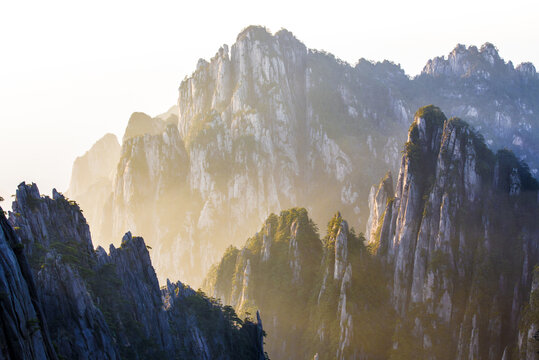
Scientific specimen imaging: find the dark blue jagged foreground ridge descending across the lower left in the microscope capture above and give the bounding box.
[2,183,264,359]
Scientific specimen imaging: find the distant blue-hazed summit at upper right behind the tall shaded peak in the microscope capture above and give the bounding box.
[414,43,539,170]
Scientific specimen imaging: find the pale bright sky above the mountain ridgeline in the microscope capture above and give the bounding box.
[0,0,539,202]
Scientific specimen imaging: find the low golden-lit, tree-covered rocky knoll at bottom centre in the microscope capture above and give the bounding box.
[204,208,393,359]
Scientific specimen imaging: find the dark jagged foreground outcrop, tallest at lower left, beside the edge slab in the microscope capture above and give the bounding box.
[10,184,119,359]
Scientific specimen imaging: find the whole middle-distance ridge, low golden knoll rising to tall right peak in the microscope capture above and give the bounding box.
[204,106,539,360]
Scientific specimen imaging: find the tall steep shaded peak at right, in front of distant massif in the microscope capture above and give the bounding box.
[372,106,539,359]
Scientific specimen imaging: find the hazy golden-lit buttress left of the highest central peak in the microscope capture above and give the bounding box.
[108,125,192,281]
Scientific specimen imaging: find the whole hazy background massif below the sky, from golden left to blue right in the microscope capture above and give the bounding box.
[70,26,539,286]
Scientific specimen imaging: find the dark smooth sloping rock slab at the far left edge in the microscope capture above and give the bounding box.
[0,208,57,360]
